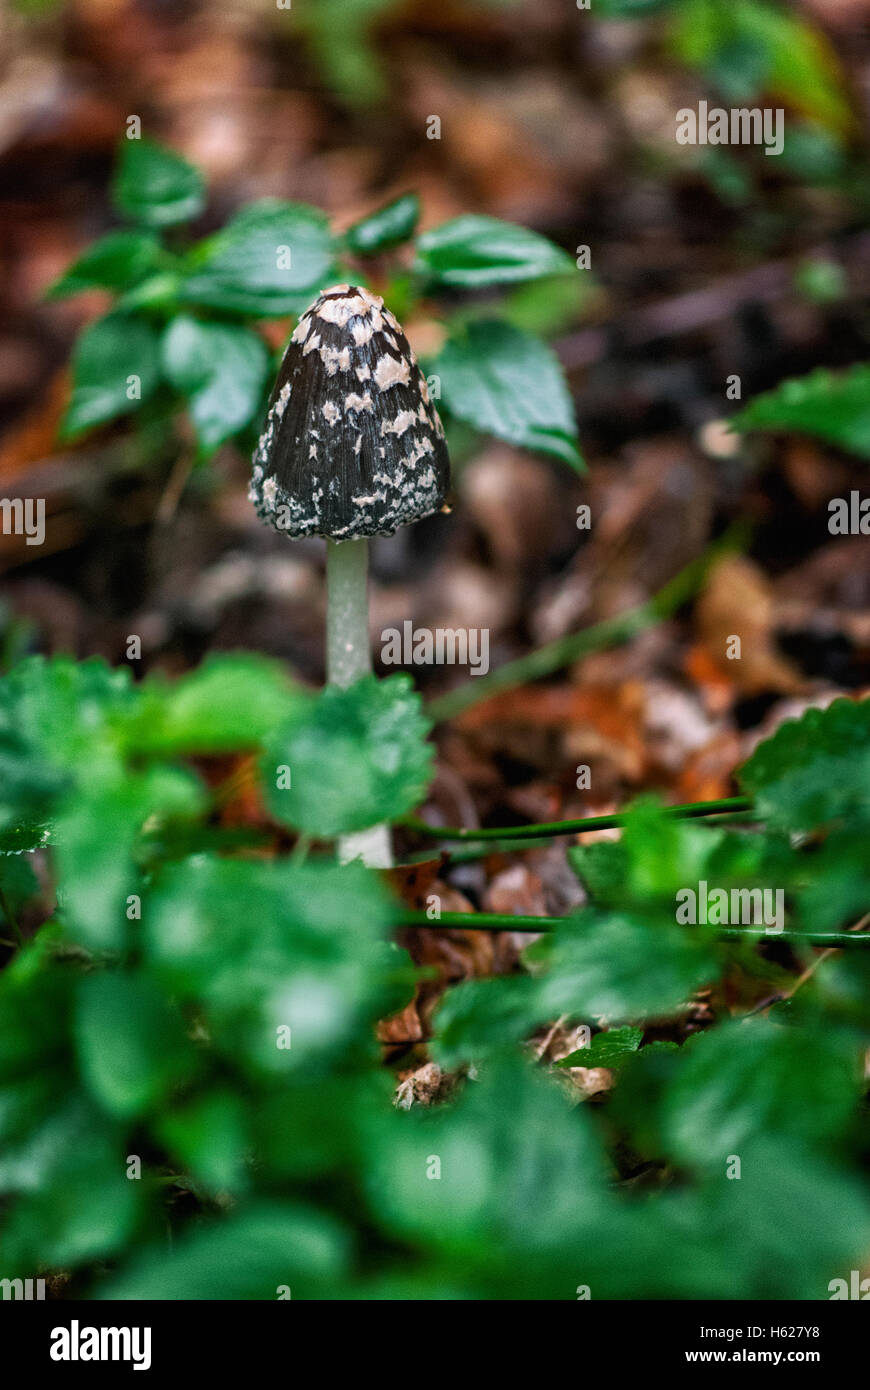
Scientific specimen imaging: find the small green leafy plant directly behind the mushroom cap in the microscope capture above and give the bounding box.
[50,138,584,468]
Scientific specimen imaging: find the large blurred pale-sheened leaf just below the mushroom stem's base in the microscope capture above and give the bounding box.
[142,855,393,1077]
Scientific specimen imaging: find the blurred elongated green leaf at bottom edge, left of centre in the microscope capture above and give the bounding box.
[100,1206,349,1302]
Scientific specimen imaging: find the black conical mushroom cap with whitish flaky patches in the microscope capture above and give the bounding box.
[250,285,450,541]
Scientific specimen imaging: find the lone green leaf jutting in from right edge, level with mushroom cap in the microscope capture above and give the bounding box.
[728,363,870,459]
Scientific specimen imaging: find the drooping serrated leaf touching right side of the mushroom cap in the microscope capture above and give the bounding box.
[432,320,584,471]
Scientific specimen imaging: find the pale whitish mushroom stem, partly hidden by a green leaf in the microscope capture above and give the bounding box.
[327,539,393,869]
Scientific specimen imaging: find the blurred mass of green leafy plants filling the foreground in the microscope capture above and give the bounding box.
[0,639,870,1300]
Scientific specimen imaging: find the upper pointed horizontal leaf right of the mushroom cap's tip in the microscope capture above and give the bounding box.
[416,213,575,289]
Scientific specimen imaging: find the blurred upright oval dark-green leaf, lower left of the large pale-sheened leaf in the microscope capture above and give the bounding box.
[74,972,195,1118]
